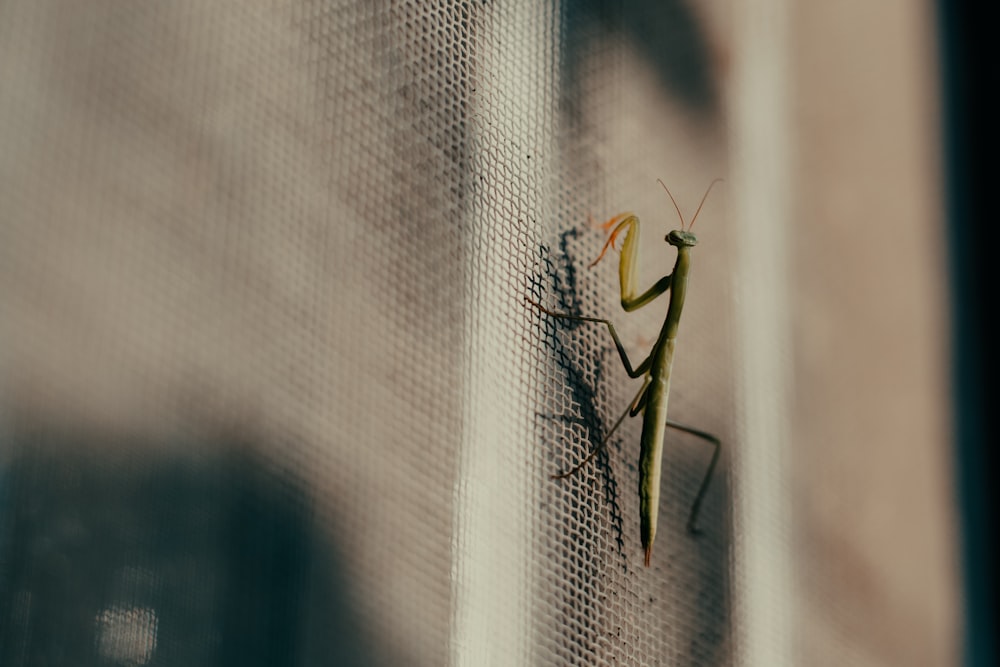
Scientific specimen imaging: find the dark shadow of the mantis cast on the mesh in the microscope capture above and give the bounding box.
[530,228,628,572]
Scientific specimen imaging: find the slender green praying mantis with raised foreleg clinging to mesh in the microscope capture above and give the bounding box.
[525,179,722,567]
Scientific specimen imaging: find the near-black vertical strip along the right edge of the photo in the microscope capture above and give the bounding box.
[937,0,1000,667]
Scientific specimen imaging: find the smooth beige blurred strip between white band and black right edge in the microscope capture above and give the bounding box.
[792,2,958,665]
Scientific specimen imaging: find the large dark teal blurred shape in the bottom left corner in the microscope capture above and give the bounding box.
[0,437,371,667]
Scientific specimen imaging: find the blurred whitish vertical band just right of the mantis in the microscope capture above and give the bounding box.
[730,0,795,667]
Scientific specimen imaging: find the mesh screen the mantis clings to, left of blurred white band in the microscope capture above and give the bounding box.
[0,0,735,665]
